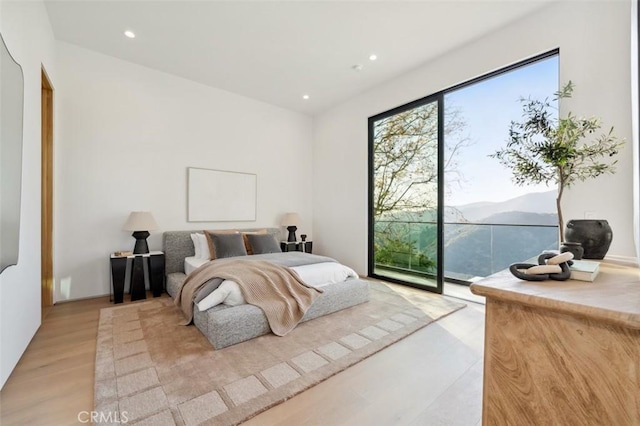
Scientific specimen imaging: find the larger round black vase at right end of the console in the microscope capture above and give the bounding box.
[564,219,613,259]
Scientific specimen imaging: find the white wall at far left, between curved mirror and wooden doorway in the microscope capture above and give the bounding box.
[0,1,57,388]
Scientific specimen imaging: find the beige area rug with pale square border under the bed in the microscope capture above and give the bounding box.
[95,281,465,426]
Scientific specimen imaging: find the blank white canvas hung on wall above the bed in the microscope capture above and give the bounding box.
[187,167,257,222]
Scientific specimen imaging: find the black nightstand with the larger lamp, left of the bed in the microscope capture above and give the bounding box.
[111,251,164,303]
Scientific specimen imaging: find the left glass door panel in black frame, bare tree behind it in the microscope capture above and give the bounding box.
[369,96,443,293]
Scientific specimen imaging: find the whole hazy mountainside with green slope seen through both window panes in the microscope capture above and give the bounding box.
[378,191,558,280]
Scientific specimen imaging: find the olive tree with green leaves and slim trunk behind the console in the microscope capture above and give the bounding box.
[490,81,625,257]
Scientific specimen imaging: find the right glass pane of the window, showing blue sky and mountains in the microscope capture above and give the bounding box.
[443,56,559,283]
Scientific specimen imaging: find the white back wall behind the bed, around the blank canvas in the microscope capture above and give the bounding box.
[54,42,313,301]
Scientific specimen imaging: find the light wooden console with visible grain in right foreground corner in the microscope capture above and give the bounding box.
[471,262,640,426]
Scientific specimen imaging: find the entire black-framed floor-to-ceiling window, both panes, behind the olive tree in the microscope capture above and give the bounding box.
[369,51,558,292]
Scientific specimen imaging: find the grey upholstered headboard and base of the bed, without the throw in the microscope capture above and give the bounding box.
[163,228,369,349]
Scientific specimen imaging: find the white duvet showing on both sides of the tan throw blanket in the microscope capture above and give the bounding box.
[196,259,358,311]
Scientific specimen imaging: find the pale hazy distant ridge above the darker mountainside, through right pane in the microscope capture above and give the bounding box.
[448,190,557,224]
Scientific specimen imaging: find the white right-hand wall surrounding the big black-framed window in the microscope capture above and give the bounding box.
[313,0,635,273]
